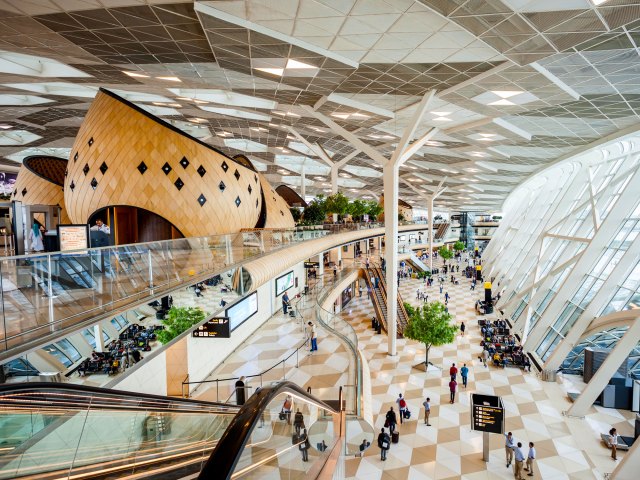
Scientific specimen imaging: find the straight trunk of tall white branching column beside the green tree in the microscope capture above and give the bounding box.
[382,162,400,356]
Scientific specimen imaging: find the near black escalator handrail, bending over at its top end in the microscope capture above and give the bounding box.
[198,382,339,480]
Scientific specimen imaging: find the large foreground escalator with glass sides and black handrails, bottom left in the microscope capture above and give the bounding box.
[0,382,338,480]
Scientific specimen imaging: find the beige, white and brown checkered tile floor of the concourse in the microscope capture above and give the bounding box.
[200,258,634,480]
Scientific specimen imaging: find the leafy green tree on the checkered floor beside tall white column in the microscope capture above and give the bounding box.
[403,302,458,371]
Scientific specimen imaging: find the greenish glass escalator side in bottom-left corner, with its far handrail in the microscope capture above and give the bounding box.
[0,384,238,479]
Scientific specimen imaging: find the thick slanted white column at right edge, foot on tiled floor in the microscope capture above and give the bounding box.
[567,317,640,417]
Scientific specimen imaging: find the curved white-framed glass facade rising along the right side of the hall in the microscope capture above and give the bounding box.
[484,134,640,369]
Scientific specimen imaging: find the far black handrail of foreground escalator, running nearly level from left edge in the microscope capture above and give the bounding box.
[0,382,239,414]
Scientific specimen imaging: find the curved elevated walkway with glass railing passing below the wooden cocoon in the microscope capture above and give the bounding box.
[0,225,422,363]
